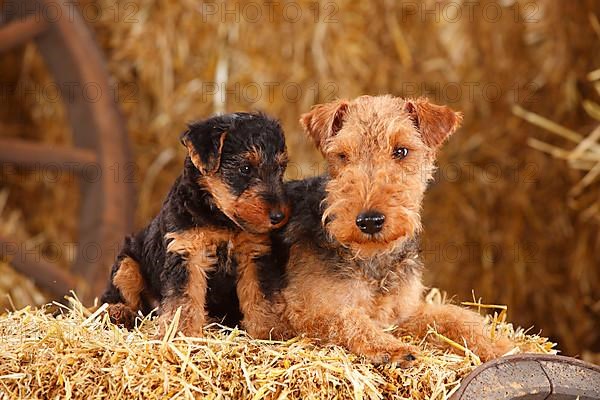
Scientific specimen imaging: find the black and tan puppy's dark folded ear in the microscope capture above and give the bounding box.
[181,119,227,174]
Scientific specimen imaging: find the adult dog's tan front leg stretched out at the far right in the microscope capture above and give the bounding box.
[400,303,514,362]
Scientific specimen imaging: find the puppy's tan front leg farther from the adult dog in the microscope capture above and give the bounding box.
[159,244,217,336]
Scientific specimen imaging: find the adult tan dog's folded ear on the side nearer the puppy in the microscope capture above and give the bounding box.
[300,100,348,151]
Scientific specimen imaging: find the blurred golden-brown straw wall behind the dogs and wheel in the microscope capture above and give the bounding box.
[0,0,600,355]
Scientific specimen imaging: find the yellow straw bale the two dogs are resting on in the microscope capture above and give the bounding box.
[0,296,556,400]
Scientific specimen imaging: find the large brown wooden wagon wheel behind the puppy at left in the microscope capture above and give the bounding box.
[0,0,133,301]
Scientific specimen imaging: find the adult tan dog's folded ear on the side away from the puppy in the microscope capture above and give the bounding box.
[403,98,462,149]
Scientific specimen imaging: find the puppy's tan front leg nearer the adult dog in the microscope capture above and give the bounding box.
[234,232,291,339]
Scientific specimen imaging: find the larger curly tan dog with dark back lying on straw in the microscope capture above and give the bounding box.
[240,96,511,364]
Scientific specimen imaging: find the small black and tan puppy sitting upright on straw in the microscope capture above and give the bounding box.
[101,113,288,336]
